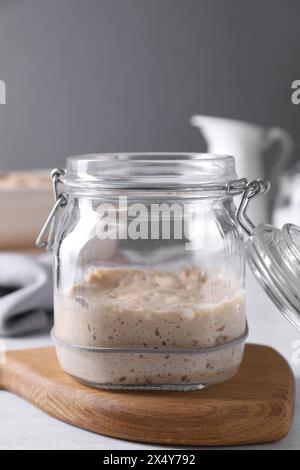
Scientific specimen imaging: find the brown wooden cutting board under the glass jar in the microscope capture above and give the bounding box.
[0,345,295,446]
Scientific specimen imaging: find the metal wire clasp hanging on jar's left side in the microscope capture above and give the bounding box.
[35,168,68,250]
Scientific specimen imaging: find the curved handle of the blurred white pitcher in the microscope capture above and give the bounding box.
[267,127,294,183]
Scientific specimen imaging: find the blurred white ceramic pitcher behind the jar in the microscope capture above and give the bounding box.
[191,115,294,222]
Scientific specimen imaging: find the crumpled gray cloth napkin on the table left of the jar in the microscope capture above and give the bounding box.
[0,253,53,336]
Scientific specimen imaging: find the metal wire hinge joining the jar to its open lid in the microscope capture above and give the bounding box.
[233,179,271,235]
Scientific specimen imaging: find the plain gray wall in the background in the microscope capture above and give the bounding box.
[0,0,300,169]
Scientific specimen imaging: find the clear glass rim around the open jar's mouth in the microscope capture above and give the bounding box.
[64,152,237,190]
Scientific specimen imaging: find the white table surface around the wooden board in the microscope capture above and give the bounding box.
[0,266,300,450]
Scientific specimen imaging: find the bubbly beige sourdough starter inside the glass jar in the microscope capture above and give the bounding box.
[55,267,246,387]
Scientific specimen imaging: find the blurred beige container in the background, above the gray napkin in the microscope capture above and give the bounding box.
[0,170,53,249]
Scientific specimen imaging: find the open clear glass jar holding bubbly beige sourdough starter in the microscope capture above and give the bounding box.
[37,154,258,390]
